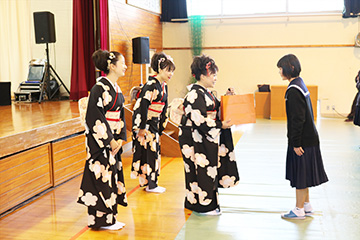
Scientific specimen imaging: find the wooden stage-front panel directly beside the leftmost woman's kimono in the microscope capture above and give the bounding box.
[52,134,86,186]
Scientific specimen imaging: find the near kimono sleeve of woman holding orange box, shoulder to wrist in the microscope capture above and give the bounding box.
[185,90,222,139]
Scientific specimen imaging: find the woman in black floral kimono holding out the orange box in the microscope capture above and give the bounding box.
[179,55,239,215]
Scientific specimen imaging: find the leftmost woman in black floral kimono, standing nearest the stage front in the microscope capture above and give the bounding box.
[78,49,127,230]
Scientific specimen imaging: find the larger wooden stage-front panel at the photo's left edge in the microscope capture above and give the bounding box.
[0,144,52,214]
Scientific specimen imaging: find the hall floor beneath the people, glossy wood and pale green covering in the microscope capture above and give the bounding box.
[0,102,360,240]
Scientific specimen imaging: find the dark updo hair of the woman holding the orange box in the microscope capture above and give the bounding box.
[190,54,219,81]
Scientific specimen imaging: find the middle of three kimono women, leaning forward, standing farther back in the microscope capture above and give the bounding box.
[131,53,175,193]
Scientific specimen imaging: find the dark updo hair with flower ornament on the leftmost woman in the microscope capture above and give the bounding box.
[92,49,122,74]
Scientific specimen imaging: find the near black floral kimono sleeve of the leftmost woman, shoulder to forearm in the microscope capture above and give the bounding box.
[85,85,114,148]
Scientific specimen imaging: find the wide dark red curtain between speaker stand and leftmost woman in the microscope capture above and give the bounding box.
[70,0,95,100]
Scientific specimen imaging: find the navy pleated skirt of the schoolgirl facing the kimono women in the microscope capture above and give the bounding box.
[286,146,328,189]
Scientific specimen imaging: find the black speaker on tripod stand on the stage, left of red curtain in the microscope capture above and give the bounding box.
[34,12,70,103]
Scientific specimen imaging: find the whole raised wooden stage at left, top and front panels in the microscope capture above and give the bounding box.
[0,100,86,214]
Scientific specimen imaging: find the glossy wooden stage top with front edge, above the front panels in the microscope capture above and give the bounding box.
[0,101,84,158]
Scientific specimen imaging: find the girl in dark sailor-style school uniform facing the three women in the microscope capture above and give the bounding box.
[277,54,328,219]
